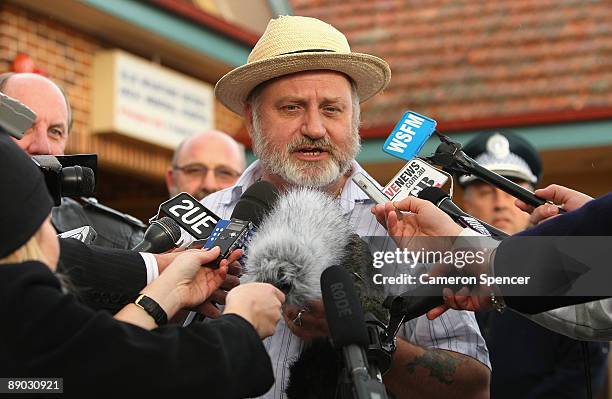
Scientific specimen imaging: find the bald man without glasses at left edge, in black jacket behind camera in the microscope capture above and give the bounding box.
[0,73,146,249]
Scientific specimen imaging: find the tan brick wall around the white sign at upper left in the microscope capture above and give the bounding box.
[0,4,242,178]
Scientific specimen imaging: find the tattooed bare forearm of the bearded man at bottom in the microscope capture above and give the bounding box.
[384,338,491,399]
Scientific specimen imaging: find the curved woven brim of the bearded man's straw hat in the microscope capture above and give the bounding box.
[215,52,391,114]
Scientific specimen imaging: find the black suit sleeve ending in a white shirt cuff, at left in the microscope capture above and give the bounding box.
[58,238,147,312]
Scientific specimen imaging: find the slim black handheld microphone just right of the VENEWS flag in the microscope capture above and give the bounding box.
[418,187,509,239]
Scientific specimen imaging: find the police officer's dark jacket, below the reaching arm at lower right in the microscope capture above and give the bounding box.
[476,311,608,399]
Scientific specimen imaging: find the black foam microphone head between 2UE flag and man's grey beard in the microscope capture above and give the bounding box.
[231,180,278,226]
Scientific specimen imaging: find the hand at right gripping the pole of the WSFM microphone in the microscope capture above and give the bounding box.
[515,184,593,225]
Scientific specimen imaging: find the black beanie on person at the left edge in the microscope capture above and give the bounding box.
[0,132,53,258]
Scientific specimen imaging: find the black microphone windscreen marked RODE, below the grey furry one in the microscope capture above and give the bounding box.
[321,266,370,348]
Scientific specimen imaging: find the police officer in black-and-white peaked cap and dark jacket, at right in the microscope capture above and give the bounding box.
[458,130,608,399]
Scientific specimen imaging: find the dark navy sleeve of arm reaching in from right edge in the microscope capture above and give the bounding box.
[494,193,612,314]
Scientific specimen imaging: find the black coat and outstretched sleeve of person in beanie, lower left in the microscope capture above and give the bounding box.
[0,262,274,398]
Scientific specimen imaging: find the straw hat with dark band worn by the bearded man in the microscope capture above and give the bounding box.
[215,16,391,114]
